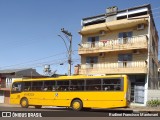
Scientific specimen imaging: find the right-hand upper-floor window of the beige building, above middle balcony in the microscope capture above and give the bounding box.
[118,32,132,44]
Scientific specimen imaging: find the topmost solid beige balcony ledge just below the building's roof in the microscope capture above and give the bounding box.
[79,15,148,35]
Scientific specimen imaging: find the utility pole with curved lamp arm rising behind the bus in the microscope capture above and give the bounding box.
[58,28,72,76]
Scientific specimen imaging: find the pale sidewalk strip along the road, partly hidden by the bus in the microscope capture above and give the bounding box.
[0,103,160,112]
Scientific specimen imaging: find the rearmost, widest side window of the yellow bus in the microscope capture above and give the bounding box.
[102,79,123,91]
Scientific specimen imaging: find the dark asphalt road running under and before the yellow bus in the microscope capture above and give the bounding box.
[0,107,160,120]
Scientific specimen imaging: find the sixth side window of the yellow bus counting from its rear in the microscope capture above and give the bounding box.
[32,81,43,91]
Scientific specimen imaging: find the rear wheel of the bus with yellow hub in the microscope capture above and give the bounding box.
[71,99,83,111]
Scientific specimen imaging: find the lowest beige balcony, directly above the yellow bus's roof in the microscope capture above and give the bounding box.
[79,61,147,75]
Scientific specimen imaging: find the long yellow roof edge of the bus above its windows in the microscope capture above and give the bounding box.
[14,75,127,82]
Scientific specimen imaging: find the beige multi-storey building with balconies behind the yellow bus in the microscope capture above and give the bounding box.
[75,4,160,105]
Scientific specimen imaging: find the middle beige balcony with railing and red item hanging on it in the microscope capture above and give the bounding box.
[78,35,148,54]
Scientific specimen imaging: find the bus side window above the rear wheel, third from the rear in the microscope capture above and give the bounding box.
[70,80,84,91]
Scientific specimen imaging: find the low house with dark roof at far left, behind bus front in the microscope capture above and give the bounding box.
[0,69,41,103]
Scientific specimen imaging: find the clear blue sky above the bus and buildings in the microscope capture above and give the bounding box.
[0,0,160,74]
